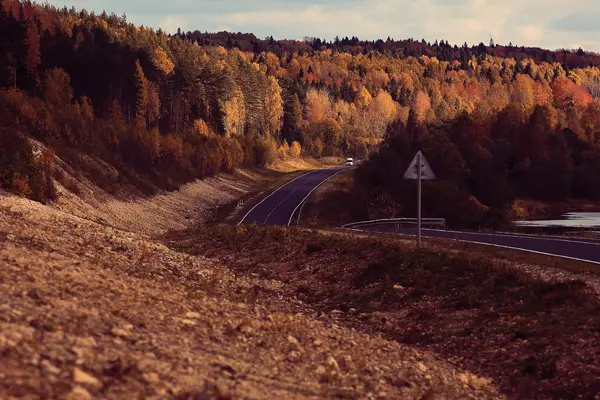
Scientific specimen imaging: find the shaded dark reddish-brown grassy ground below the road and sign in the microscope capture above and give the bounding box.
[167,226,600,398]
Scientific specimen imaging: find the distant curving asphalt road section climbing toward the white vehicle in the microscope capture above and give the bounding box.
[240,167,348,226]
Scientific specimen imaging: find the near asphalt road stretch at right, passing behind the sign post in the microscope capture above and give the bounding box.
[360,226,600,264]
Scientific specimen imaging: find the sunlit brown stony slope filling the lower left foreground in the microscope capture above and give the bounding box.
[0,193,502,399]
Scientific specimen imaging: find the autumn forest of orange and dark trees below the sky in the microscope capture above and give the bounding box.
[0,0,600,226]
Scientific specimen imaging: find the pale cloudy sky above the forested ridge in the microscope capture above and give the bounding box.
[50,0,600,52]
